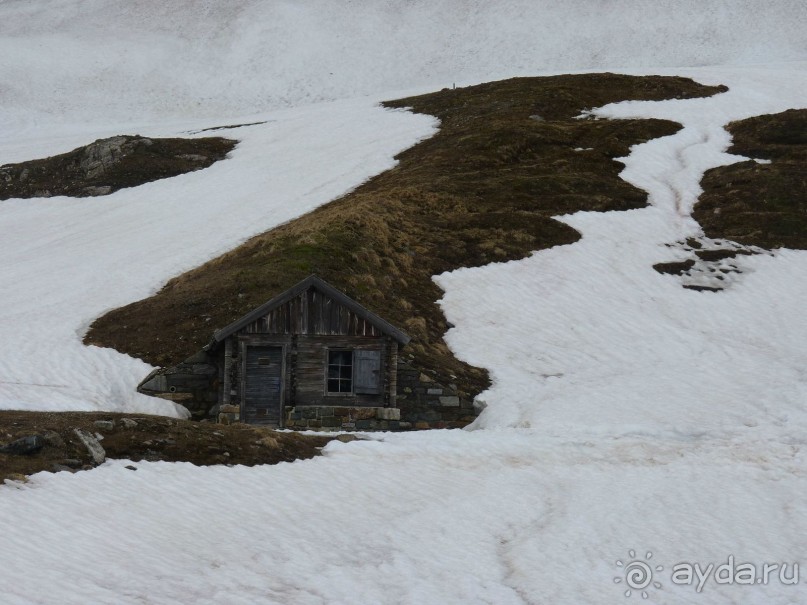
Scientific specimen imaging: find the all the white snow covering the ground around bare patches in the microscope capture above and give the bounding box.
[0,0,807,605]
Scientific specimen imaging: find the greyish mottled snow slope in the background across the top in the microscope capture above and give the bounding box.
[0,0,807,123]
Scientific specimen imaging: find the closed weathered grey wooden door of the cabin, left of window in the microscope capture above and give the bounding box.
[243,346,283,426]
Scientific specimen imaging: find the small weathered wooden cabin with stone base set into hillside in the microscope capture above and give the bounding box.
[138,276,409,428]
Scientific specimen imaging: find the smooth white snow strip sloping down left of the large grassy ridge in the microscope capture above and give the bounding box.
[0,101,434,415]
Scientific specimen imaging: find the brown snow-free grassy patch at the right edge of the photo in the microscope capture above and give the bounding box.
[693,109,807,249]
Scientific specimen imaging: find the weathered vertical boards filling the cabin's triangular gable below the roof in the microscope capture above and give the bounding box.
[240,288,382,337]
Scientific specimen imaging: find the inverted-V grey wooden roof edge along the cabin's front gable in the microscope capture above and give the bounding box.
[205,275,411,349]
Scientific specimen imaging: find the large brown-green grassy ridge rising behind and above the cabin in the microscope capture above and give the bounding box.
[86,74,722,396]
